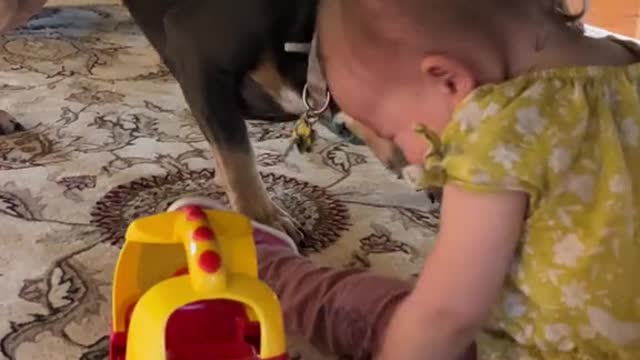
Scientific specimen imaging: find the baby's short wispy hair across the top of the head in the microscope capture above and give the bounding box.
[318,0,588,71]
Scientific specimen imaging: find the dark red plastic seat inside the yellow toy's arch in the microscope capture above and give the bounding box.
[165,300,260,360]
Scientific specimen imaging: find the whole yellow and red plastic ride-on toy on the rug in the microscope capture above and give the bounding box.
[109,206,288,360]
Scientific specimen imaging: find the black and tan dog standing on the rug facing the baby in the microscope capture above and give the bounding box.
[0,0,410,240]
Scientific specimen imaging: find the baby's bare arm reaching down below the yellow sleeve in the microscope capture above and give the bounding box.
[377,185,528,360]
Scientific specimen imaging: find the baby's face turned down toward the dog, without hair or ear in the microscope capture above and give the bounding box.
[321,39,454,164]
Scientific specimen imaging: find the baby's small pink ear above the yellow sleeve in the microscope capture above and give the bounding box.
[420,55,476,105]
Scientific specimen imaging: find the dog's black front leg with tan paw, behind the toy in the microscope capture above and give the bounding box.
[165,0,302,239]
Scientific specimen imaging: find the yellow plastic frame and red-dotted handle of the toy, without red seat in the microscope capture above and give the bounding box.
[113,207,286,360]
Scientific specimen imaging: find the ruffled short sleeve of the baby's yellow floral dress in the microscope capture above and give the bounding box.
[423,82,553,202]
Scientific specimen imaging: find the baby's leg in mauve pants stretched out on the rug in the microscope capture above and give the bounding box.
[258,246,412,359]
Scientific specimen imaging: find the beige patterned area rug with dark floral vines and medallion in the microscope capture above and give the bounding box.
[0,1,437,360]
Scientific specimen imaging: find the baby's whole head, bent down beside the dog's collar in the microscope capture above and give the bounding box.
[318,0,584,163]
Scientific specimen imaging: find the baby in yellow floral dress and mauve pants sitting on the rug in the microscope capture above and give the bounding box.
[174,0,640,360]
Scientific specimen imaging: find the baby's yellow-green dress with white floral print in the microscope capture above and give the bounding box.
[424,64,640,360]
